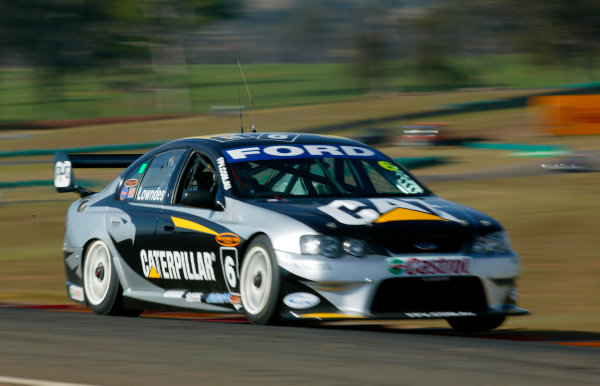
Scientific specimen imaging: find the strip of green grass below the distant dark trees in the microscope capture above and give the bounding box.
[0,55,593,122]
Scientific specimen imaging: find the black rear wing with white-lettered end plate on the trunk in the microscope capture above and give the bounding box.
[54,152,142,197]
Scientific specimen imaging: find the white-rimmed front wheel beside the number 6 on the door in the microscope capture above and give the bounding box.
[240,235,281,325]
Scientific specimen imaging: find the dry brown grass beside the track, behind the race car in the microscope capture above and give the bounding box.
[0,94,600,331]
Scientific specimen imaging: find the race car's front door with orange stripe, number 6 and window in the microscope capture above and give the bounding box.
[156,151,241,305]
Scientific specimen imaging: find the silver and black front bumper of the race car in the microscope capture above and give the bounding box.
[276,251,529,320]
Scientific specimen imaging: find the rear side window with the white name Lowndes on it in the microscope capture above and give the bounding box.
[136,149,185,202]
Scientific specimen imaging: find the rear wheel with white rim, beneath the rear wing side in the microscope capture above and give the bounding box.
[83,240,142,316]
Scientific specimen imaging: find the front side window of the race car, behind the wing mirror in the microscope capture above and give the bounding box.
[176,152,218,202]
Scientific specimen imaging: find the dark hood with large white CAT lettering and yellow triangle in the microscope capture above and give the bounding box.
[250,196,502,253]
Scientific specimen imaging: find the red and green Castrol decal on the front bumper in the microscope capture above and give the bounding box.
[383,257,471,276]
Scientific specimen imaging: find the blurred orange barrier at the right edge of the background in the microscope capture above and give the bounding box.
[528,95,600,135]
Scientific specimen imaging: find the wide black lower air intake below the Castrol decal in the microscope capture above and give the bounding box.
[371,276,487,316]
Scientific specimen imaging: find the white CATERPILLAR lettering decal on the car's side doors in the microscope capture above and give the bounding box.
[140,249,217,281]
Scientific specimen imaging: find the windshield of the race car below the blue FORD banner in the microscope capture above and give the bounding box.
[228,157,427,198]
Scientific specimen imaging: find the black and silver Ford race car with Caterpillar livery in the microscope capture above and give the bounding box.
[54,133,528,332]
